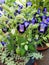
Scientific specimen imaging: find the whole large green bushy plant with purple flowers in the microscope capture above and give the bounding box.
[0,0,49,64]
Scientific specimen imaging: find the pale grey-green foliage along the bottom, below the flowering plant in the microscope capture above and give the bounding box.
[0,44,43,65]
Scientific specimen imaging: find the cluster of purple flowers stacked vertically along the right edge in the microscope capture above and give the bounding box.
[38,7,49,33]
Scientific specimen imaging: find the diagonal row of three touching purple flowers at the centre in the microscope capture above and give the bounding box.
[17,18,37,33]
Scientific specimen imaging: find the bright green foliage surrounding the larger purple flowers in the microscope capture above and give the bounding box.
[0,0,49,56]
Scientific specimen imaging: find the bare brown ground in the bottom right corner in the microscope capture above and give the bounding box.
[37,49,49,65]
